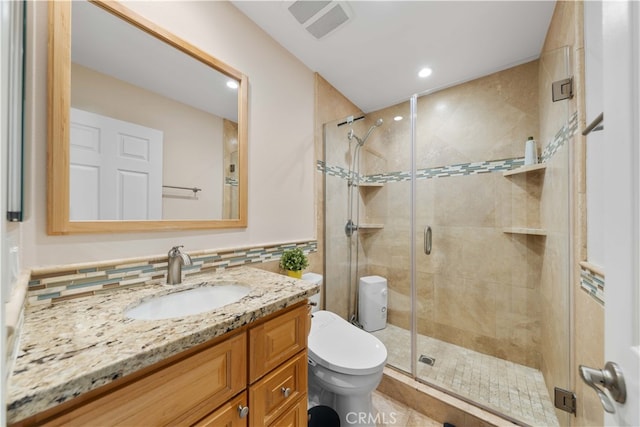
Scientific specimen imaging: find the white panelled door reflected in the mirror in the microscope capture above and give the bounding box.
[69,108,163,221]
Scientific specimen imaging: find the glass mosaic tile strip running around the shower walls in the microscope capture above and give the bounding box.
[316,112,578,184]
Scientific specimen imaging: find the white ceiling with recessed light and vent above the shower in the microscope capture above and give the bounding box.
[232,0,555,112]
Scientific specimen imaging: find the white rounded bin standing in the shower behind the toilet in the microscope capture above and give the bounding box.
[358,276,387,332]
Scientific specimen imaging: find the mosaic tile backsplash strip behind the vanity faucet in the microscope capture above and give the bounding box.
[27,240,318,305]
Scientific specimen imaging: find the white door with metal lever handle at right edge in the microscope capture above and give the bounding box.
[599,1,640,426]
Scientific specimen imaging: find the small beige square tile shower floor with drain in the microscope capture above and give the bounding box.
[373,324,559,426]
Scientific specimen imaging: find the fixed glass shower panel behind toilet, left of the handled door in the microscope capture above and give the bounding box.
[321,102,412,373]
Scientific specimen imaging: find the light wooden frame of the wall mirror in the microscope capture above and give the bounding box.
[47,1,249,235]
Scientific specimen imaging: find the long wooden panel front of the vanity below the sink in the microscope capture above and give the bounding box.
[40,334,247,426]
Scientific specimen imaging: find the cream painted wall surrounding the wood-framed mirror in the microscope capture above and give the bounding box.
[20,1,316,268]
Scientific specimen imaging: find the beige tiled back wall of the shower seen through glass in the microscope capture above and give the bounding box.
[361,61,544,367]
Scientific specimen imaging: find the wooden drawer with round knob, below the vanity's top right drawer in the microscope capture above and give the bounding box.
[249,351,307,426]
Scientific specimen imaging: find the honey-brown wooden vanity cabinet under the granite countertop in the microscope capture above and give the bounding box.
[14,303,310,427]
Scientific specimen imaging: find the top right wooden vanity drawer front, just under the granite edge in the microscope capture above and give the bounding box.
[249,305,309,383]
